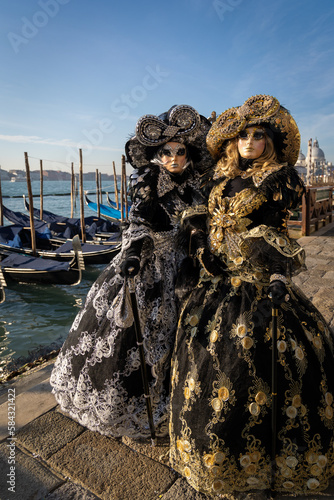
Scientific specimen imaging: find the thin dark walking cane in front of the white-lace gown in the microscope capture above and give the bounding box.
[129,267,157,446]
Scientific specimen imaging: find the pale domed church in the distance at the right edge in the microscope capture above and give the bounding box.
[296,139,334,181]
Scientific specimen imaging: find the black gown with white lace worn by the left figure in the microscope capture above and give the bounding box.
[51,165,203,438]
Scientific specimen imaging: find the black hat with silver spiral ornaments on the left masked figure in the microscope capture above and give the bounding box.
[125,104,212,170]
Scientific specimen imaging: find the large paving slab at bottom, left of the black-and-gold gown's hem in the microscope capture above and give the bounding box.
[48,431,177,500]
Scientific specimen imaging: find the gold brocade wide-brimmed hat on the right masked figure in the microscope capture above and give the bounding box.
[206,95,300,165]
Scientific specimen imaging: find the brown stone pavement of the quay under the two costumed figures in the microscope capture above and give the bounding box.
[0,223,334,500]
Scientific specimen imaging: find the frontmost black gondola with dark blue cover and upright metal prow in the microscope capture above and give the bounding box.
[0,236,85,290]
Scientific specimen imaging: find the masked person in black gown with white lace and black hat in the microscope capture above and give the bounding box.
[51,105,212,438]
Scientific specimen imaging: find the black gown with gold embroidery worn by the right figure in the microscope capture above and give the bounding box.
[170,166,334,498]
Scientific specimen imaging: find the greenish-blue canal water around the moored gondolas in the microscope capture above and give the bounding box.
[0,181,118,378]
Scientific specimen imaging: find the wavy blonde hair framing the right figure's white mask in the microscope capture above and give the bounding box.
[217,135,279,177]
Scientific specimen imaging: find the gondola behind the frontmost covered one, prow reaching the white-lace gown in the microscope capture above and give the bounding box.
[0,224,120,264]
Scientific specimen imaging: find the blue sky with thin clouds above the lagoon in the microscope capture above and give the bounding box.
[0,0,334,174]
